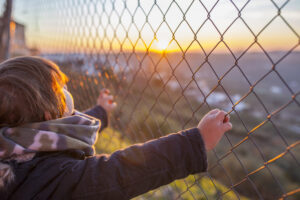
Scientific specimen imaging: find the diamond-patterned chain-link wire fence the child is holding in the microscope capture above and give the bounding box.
[2,0,300,199]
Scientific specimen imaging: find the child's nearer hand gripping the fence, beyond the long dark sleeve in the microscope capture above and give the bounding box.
[197,109,232,150]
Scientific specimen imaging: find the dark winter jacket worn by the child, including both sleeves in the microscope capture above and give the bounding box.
[0,106,207,200]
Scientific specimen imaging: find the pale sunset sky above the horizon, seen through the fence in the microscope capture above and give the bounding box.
[9,0,300,53]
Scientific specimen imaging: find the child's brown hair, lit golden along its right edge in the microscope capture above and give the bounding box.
[0,57,67,127]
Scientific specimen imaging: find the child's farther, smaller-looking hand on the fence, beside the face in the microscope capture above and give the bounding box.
[97,89,117,112]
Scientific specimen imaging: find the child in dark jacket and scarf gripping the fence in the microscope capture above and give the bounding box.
[0,57,232,200]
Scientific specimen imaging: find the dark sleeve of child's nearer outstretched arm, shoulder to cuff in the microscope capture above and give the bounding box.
[74,128,207,199]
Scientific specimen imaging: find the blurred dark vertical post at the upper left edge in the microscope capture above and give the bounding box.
[0,0,13,60]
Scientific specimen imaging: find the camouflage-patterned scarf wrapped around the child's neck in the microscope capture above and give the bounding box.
[0,111,101,161]
